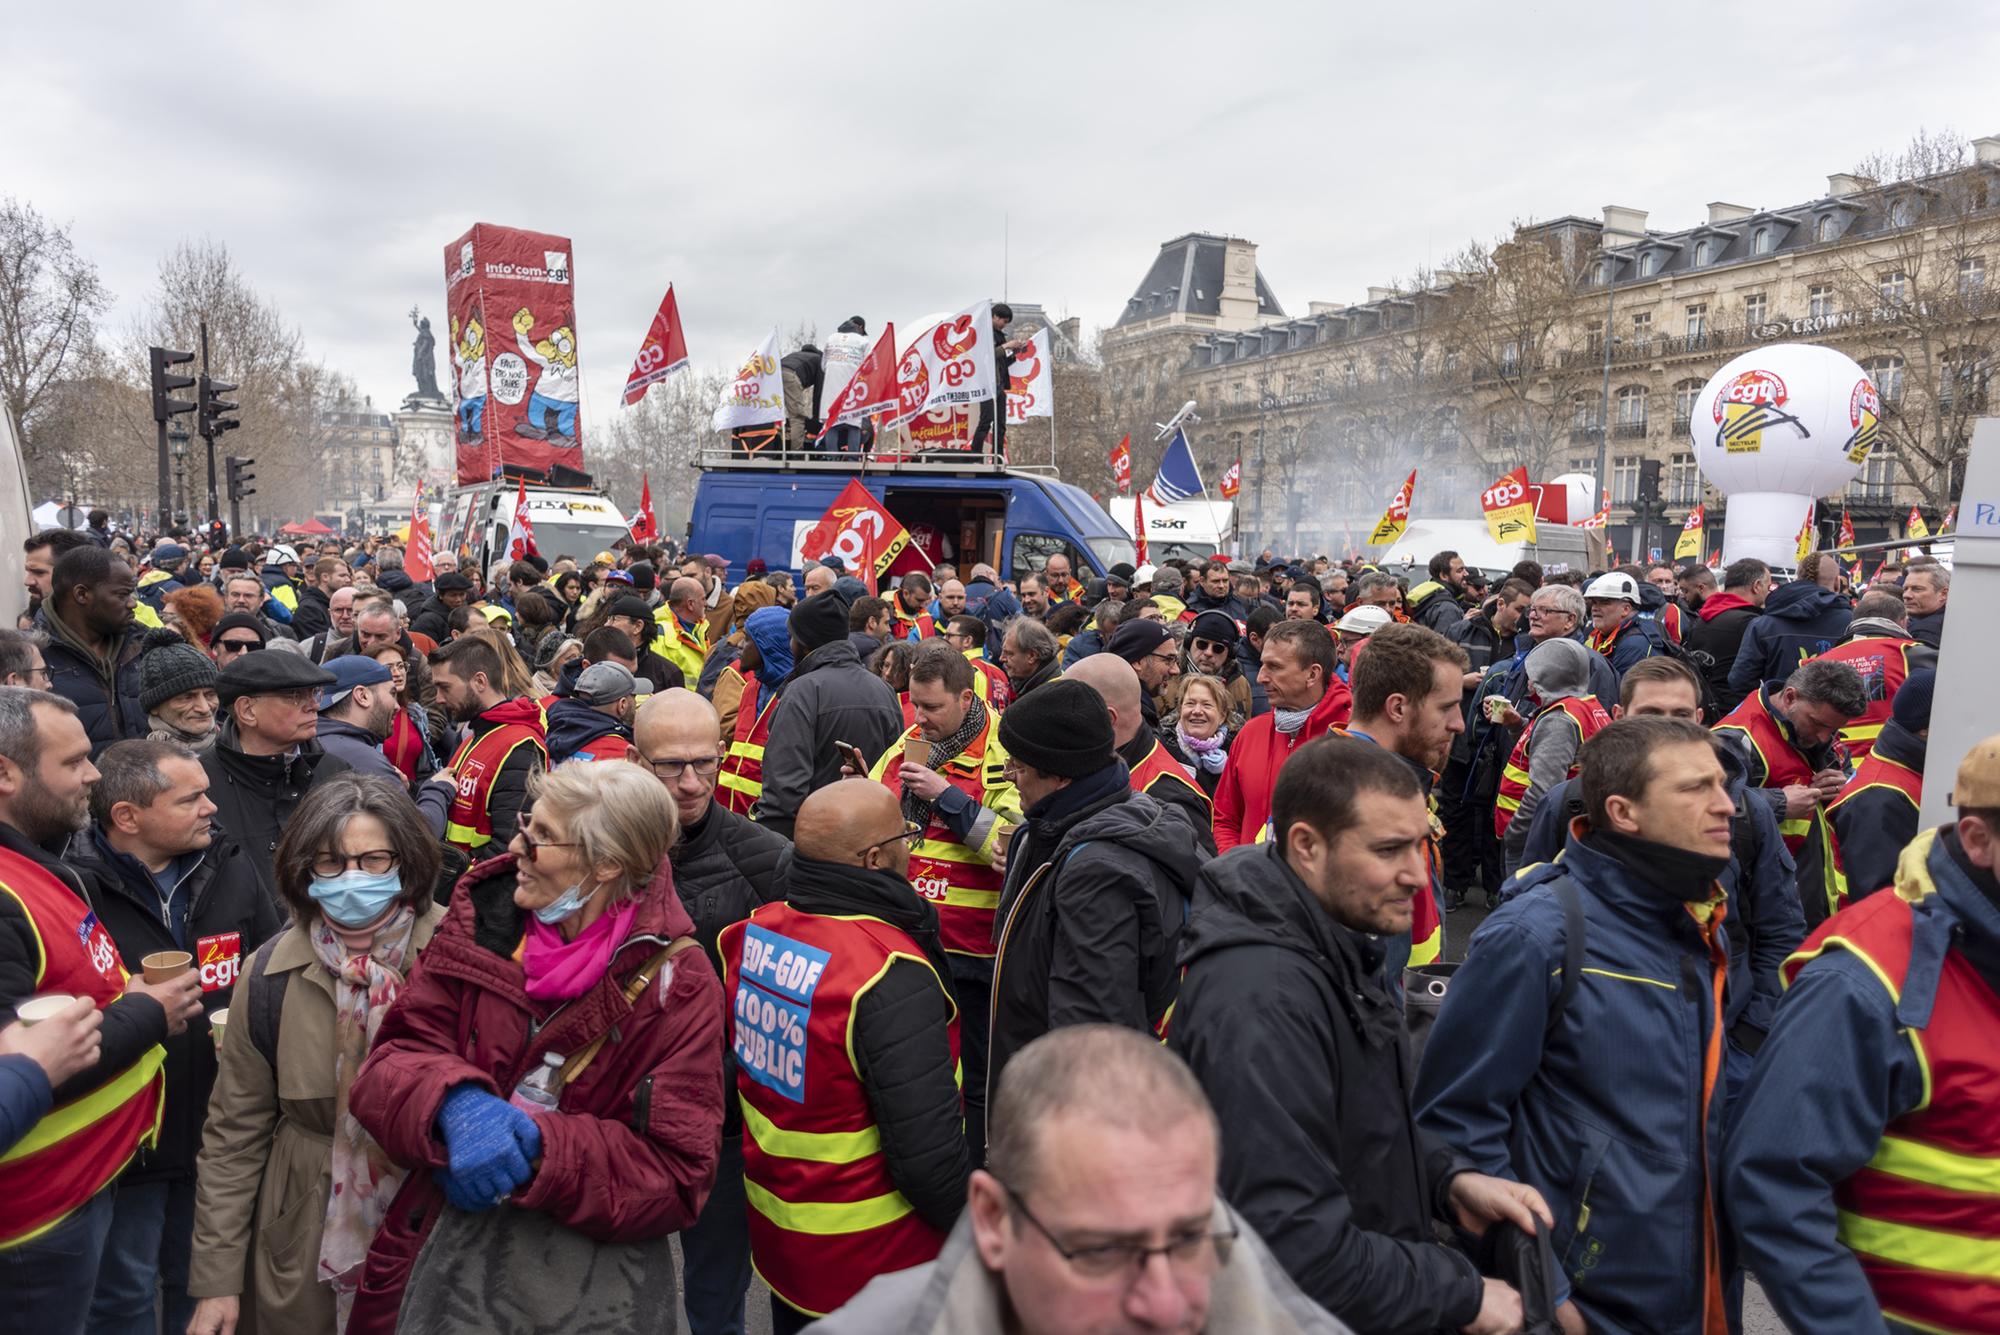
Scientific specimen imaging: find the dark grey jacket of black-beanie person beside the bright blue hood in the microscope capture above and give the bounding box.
[756,638,904,837]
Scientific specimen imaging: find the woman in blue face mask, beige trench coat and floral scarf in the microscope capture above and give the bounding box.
[188,773,444,1335]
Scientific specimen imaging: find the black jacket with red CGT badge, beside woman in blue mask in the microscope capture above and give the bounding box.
[64,825,284,1181]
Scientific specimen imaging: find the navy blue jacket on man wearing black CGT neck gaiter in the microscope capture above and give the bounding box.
[1416,837,1748,1335]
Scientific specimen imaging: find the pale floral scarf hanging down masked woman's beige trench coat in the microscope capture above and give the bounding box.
[306,905,416,1331]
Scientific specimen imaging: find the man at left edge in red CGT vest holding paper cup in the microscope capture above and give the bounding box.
[0,685,200,1335]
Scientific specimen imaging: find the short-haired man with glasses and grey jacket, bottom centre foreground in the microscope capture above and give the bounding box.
[806,1025,1348,1335]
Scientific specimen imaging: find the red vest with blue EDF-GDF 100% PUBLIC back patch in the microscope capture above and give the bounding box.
[720,903,960,1317]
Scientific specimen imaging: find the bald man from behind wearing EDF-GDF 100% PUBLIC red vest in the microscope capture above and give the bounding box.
[720,779,972,1335]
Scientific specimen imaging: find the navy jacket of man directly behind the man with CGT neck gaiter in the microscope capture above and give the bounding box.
[1500,747,1808,1055]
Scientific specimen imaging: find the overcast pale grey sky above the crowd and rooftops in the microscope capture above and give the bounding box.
[0,0,2000,437]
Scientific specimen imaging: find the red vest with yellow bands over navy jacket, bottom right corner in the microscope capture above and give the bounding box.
[1784,879,2000,1331]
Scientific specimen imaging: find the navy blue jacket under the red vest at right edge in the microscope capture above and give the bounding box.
[1724,827,2000,1335]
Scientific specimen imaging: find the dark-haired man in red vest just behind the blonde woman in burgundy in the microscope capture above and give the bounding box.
[416,638,548,861]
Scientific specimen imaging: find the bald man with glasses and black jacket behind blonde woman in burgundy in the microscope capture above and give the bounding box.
[630,685,792,1333]
